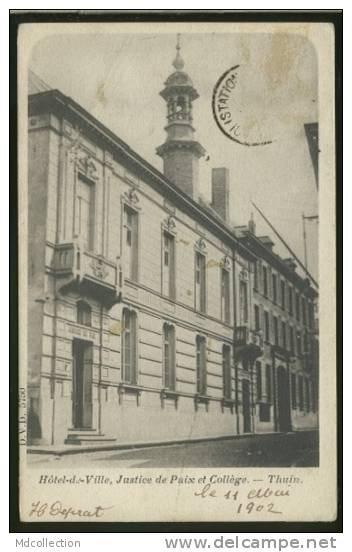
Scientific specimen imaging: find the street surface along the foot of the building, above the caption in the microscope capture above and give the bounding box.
[28,432,319,468]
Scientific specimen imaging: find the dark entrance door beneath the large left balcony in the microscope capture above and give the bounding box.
[72,339,93,429]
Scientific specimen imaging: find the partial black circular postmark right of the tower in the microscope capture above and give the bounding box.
[212,65,273,146]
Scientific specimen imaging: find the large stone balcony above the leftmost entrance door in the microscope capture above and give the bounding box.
[52,241,123,307]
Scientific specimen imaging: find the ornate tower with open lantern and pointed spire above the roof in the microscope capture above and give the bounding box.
[157,35,205,200]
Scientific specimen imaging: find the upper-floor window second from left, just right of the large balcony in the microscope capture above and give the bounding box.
[123,205,138,281]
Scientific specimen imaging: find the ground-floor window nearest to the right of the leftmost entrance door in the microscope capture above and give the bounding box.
[122,309,137,384]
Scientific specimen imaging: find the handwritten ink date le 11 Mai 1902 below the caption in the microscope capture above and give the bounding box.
[194,483,289,514]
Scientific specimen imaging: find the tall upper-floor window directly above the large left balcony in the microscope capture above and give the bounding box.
[75,174,95,251]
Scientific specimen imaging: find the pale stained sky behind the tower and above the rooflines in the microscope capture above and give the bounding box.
[30,29,318,278]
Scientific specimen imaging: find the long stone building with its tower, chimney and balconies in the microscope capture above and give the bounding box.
[28,45,317,445]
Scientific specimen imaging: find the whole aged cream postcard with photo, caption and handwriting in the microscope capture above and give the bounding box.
[18,21,337,523]
